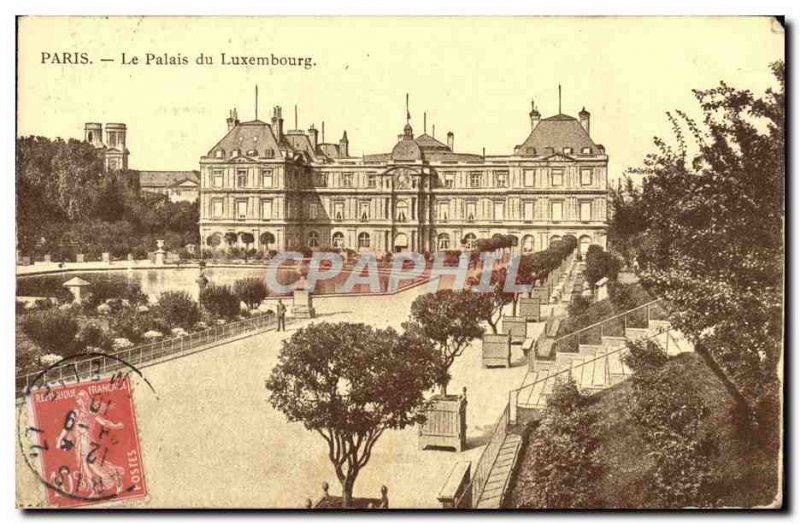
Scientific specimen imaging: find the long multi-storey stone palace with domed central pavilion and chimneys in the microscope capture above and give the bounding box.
[200,104,608,253]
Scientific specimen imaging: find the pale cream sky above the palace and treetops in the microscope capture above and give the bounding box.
[17,17,784,180]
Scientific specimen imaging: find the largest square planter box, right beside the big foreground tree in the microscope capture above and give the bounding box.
[419,388,467,452]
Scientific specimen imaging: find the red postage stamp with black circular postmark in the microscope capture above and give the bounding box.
[29,376,147,507]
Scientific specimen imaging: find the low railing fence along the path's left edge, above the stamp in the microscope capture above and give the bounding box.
[16,315,276,397]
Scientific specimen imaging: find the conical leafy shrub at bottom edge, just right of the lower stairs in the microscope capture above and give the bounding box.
[517,375,602,509]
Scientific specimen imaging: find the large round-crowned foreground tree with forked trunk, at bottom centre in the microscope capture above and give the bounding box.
[266,322,437,508]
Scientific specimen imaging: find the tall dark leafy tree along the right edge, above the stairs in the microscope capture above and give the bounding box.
[624,63,786,423]
